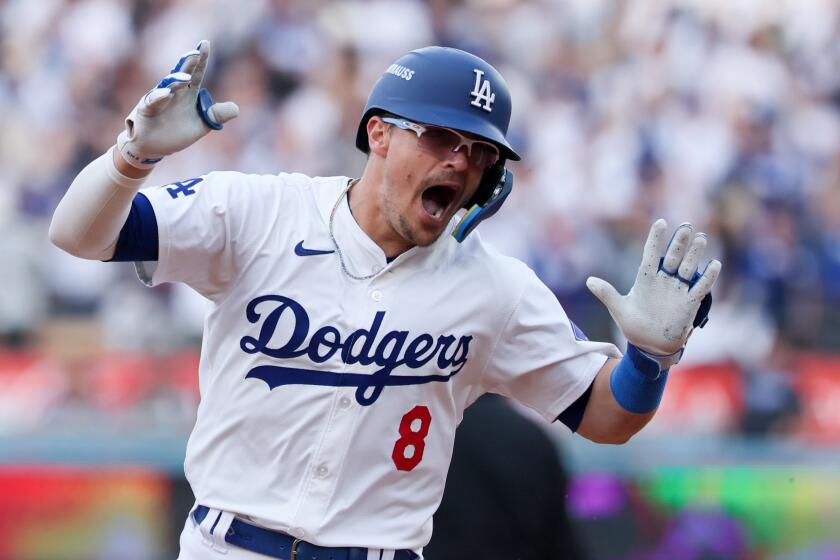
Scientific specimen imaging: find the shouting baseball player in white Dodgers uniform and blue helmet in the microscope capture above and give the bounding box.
[50,41,720,560]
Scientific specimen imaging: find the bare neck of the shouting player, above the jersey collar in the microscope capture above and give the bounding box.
[347,173,414,259]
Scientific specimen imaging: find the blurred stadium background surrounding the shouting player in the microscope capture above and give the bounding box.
[0,0,840,560]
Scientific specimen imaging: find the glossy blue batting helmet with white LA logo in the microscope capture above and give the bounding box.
[356,47,520,160]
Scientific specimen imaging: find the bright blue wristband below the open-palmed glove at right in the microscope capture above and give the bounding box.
[610,342,668,414]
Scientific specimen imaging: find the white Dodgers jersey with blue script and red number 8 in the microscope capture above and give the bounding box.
[133,172,620,552]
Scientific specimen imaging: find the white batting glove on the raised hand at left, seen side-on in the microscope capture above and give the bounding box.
[117,40,239,169]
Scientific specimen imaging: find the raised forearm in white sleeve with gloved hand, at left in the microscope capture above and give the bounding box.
[50,41,239,260]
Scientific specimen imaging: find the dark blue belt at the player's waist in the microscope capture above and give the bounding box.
[192,506,420,560]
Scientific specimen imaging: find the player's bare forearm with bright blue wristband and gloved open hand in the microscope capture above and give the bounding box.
[578,220,721,443]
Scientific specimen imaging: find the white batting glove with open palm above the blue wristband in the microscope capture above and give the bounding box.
[586,219,721,369]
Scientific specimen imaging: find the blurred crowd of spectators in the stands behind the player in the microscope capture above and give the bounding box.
[0,0,840,436]
